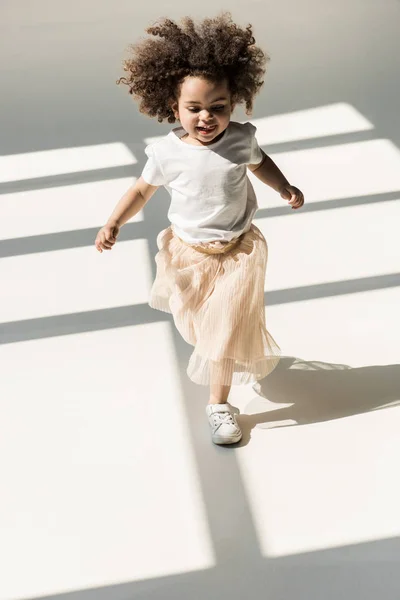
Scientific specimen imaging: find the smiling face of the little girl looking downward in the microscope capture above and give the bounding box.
[172,77,234,145]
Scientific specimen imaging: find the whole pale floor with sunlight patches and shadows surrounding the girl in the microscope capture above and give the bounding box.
[0,0,400,600]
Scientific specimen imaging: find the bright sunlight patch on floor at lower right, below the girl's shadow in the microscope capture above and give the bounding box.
[237,407,400,557]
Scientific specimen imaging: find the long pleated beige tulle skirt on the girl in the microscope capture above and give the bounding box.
[149,223,280,385]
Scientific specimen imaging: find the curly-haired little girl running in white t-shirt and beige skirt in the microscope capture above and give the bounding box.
[95,13,304,444]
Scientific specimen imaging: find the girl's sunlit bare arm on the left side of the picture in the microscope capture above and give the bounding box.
[95,177,159,252]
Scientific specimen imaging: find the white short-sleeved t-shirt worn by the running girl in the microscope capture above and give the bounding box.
[142,121,263,244]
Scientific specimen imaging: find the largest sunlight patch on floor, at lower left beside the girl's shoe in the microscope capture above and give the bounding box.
[0,323,214,600]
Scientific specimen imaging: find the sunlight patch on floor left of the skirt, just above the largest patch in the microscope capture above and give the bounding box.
[0,240,152,322]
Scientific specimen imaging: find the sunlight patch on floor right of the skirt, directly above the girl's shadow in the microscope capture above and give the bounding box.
[265,286,400,367]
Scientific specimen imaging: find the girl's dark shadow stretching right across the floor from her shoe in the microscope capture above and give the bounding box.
[238,357,400,445]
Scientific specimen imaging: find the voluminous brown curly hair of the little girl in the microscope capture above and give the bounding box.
[117,12,269,123]
